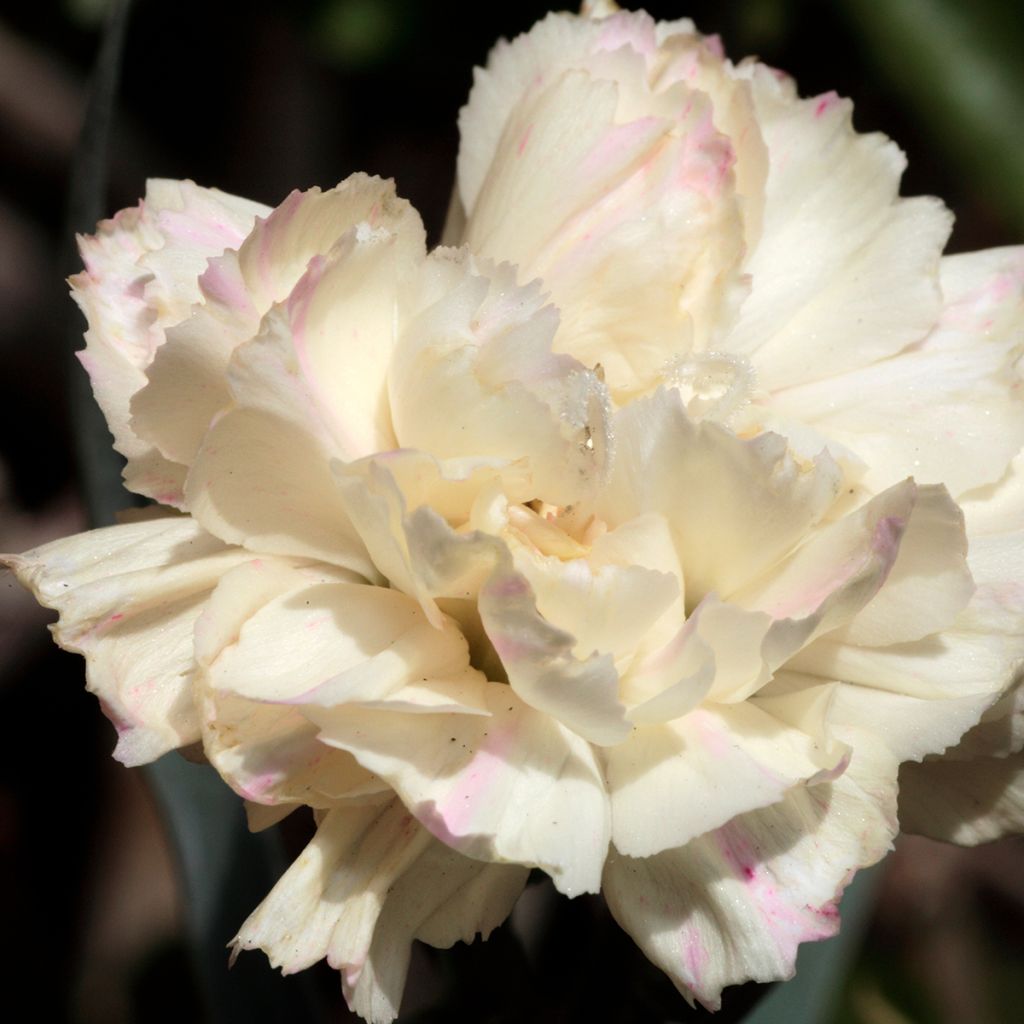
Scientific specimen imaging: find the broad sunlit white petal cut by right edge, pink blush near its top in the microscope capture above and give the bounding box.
[771,249,1024,495]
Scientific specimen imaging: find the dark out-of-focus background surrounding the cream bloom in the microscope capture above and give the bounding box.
[0,0,1024,1024]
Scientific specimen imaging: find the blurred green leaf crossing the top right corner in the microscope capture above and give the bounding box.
[841,0,1024,229]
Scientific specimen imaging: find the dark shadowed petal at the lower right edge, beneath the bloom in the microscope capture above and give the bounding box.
[899,752,1024,846]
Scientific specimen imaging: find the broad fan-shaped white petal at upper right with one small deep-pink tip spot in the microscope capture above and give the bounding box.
[722,63,951,389]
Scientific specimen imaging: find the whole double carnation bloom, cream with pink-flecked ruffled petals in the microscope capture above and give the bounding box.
[9,13,1024,1022]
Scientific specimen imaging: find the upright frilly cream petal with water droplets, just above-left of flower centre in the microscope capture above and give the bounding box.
[388,250,608,505]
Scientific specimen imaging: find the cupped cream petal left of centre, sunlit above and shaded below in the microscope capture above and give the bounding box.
[185,200,423,579]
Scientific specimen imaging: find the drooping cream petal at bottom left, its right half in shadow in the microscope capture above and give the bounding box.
[234,801,527,1024]
